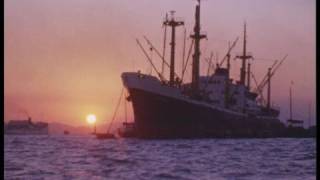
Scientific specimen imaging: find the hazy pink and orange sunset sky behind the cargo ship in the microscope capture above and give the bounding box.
[4,0,315,125]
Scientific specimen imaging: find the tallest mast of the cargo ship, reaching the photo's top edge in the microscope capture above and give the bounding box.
[190,0,207,96]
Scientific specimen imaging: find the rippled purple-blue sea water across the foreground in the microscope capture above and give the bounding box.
[4,135,316,180]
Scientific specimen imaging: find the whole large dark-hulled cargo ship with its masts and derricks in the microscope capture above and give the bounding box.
[121,1,312,138]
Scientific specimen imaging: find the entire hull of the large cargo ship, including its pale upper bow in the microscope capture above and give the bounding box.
[122,72,285,138]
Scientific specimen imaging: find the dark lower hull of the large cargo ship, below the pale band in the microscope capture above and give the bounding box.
[128,88,284,138]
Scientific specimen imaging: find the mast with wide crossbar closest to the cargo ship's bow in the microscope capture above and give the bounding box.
[163,11,184,86]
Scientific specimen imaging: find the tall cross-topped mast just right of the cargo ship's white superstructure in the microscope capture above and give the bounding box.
[236,22,252,85]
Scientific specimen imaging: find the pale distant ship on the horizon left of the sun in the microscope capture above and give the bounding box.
[4,117,49,135]
